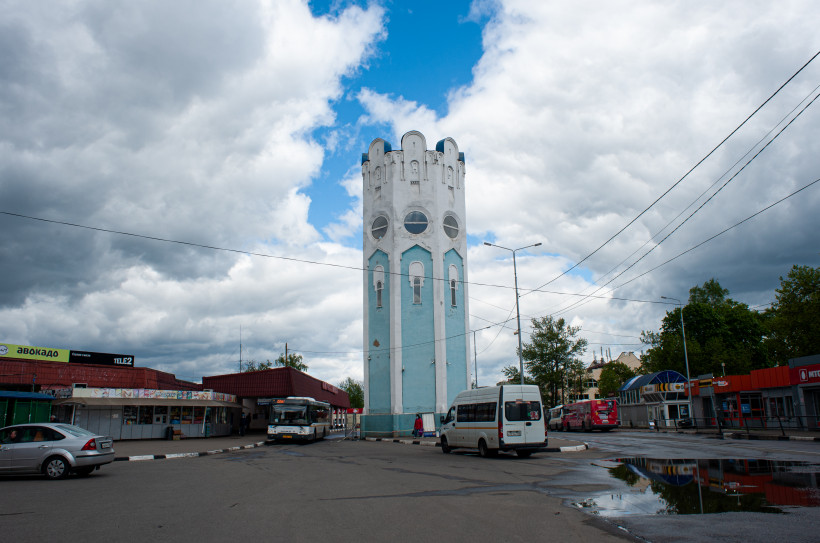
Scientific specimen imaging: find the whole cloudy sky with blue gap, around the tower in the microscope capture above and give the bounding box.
[0,0,820,385]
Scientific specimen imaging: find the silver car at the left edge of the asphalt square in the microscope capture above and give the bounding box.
[0,423,114,479]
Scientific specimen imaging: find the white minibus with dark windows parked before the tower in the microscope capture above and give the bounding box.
[441,385,547,458]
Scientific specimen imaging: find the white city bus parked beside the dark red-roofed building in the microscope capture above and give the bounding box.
[268,396,330,443]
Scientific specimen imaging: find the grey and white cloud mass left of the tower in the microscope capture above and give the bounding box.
[0,0,384,380]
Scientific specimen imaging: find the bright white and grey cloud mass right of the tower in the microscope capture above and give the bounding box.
[362,2,820,375]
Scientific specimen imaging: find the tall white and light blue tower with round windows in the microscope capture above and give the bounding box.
[362,131,471,435]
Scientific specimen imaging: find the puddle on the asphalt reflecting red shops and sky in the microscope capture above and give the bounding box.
[573,458,820,517]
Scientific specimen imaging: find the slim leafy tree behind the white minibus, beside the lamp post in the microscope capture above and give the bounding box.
[522,316,587,405]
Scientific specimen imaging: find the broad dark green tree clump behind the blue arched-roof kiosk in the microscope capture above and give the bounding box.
[641,279,771,377]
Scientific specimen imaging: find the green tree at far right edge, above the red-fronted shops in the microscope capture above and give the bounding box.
[766,266,820,365]
